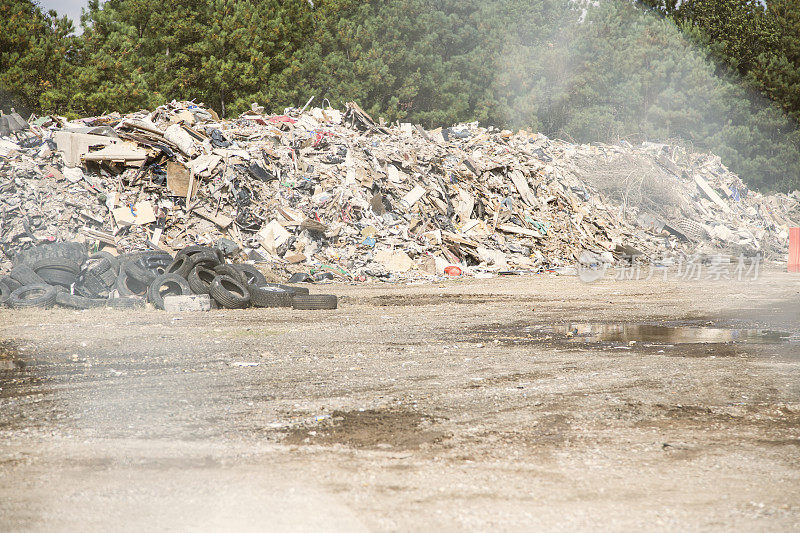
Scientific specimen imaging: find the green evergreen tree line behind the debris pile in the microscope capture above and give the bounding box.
[0,0,800,191]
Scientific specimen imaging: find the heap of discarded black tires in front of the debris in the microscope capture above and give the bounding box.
[0,243,338,309]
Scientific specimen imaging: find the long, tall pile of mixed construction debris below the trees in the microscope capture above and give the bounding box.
[0,102,800,280]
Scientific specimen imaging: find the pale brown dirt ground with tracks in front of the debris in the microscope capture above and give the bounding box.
[0,271,800,532]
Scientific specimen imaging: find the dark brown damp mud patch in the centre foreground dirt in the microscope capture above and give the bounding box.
[283,409,449,450]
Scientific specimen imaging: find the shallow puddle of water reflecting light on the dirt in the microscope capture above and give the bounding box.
[532,323,800,344]
